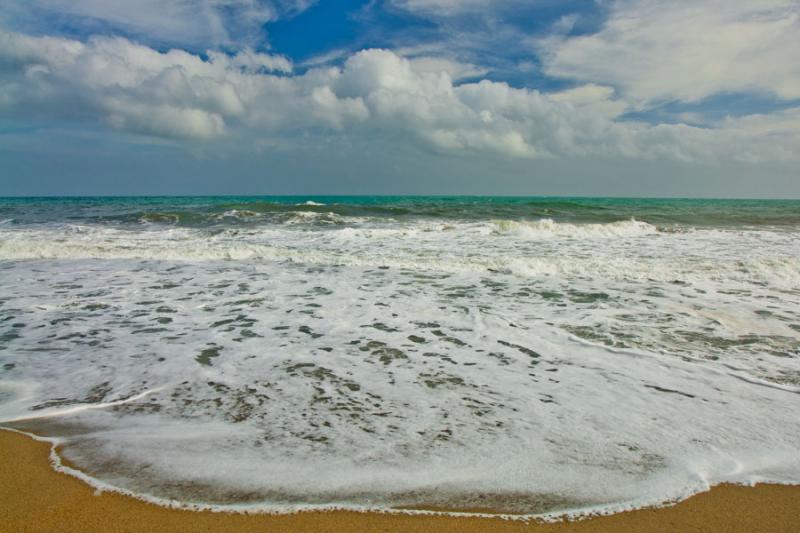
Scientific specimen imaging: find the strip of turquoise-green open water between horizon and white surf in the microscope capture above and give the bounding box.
[0,196,800,226]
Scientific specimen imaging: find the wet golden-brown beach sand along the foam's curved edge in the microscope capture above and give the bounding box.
[0,431,800,533]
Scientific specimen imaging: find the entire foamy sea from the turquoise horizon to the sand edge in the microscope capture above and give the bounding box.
[0,197,800,516]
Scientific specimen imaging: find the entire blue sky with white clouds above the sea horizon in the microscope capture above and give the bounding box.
[0,0,800,198]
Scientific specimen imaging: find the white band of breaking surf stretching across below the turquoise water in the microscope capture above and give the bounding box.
[0,221,800,287]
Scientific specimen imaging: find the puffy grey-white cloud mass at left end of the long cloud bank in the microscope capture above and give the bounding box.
[0,32,291,139]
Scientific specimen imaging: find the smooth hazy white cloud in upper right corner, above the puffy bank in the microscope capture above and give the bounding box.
[541,0,800,106]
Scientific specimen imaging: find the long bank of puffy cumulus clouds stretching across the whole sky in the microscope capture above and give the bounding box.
[0,33,800,161]
